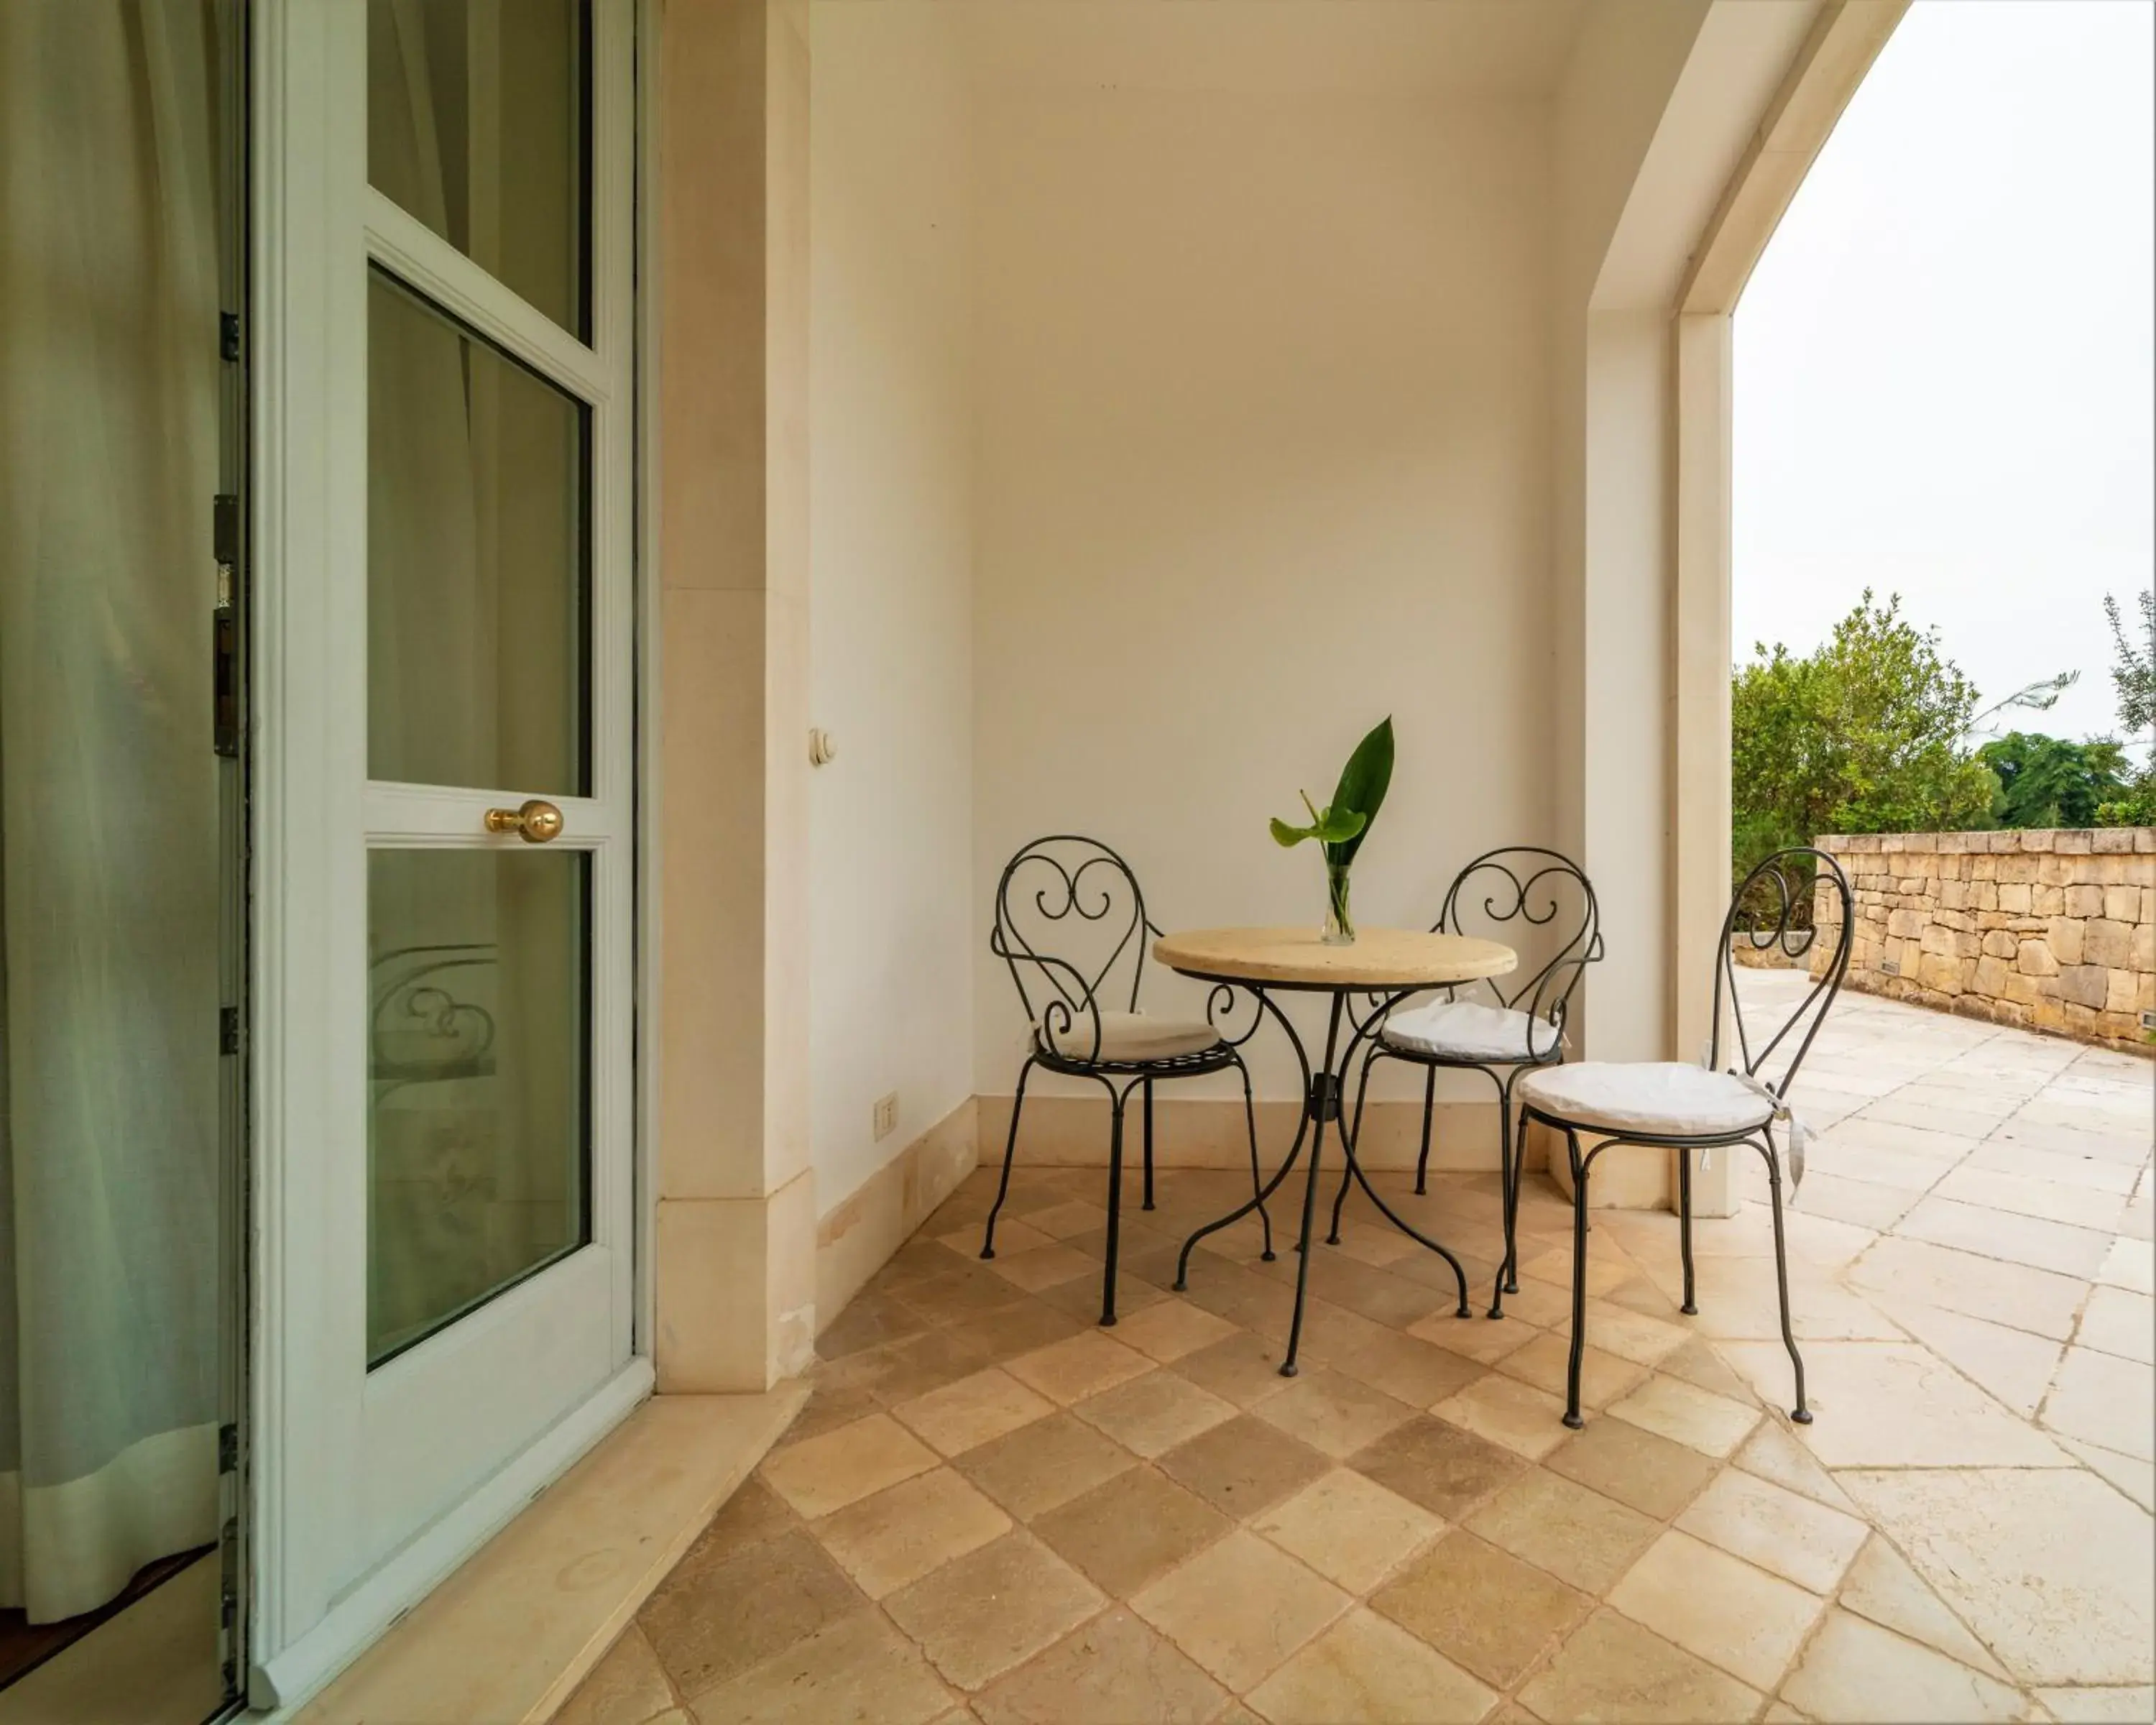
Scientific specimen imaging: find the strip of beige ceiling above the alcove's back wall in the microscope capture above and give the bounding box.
[942,0,1585,97]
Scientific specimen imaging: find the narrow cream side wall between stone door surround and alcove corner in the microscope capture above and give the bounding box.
[802,4,985,1214]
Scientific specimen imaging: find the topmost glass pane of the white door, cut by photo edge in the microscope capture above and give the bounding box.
[367,0,591,341]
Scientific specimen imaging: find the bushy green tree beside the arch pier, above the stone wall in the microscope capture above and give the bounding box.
[1731,589,1994,875]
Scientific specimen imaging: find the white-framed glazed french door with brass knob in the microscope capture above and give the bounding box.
[254,0,649,1697]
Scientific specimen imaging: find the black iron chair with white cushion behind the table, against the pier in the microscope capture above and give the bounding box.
[1326,845,1602,1294]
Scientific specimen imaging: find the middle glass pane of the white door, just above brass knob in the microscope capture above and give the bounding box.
[367,270,591,796]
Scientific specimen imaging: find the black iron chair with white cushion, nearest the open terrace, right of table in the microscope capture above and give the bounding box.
[1490,847,1854,1430]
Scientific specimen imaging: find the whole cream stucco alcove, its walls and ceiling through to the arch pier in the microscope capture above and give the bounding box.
[811,0,1815,1147]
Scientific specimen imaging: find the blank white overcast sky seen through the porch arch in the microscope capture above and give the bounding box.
[1733,0,2156,737]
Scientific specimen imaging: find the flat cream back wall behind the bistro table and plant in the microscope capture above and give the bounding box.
[975,84,1557,1098]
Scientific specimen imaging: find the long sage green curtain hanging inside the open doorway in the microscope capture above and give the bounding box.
[0,0,220,1622]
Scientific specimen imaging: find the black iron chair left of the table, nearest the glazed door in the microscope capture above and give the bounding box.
[981,832,1274,1324]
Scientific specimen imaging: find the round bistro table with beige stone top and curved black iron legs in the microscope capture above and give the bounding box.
[1153,929,1520,1378]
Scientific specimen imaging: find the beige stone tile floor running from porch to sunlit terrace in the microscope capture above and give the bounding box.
[563,972,2156,1725]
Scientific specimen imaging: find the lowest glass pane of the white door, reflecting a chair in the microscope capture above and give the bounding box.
[367,847,591,1367]
